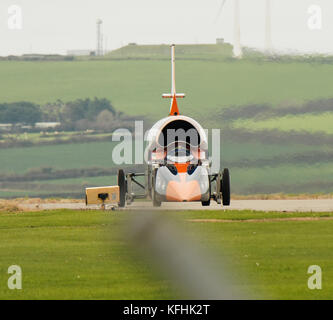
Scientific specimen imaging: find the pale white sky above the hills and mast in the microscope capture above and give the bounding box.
[0,0,333,55]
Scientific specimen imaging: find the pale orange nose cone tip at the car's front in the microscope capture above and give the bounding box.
[166,173,201,202]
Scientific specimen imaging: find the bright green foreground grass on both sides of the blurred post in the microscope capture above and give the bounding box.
[0,210,333,299]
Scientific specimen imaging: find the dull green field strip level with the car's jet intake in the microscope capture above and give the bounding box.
[0,140,328,174]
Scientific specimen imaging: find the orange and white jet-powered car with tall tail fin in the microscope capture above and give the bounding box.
[86,45,230,207]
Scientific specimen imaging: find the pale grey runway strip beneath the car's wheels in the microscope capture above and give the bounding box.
[20,199,333,212]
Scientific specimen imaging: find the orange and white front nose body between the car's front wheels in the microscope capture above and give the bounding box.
[156,163,209,202]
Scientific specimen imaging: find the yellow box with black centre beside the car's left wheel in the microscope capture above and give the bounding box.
[86,186,119,205]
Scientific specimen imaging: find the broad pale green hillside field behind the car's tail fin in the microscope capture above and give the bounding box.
[0,49,333,119]
